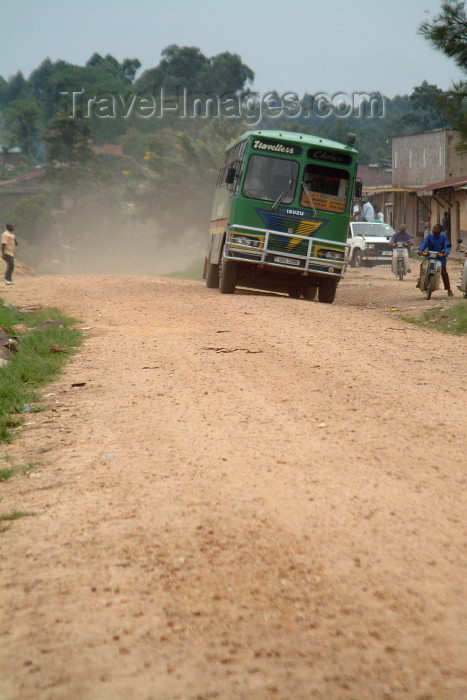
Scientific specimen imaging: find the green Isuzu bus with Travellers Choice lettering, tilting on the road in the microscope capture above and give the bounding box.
[203,131,361,304]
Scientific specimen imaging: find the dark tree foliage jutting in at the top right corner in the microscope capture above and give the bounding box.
[419,0,467,151]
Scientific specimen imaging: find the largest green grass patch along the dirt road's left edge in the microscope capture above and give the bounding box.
[0,299,82,443]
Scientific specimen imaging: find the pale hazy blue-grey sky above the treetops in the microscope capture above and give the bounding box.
[0,0,465,98]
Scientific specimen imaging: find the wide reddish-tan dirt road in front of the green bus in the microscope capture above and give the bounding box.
[0,268,467,700]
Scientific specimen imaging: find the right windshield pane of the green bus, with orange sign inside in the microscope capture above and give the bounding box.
[300,163,349,212]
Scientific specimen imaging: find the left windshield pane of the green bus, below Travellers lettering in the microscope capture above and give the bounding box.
[243,154,298,204]
